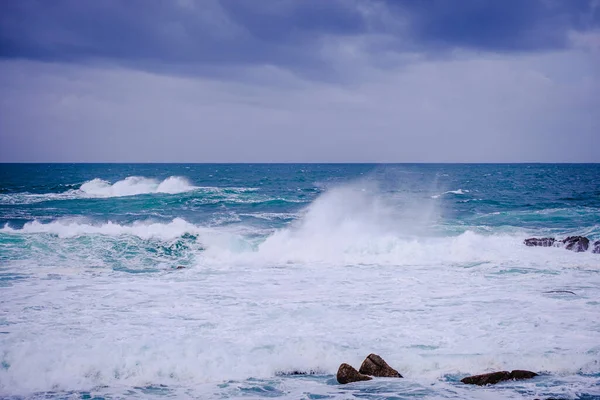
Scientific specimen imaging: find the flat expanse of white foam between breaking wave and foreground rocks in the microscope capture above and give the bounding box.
[0,245,600,398]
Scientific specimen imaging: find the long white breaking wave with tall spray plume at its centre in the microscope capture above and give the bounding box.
[0,186,597,266]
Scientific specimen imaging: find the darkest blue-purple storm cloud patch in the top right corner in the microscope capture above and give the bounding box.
[390,0,600,52]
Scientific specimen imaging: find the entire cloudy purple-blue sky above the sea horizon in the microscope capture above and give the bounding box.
[0,0,600,163]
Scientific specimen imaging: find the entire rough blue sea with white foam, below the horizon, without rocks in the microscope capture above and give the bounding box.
[0,164,600,400]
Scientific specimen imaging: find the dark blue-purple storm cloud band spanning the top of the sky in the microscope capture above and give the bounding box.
[0,0,600,76]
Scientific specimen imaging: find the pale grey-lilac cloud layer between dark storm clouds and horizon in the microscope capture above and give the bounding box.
[0,38,600,162]
